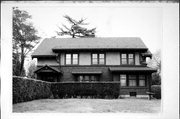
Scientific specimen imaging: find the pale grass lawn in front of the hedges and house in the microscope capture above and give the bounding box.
[13,99,161,113]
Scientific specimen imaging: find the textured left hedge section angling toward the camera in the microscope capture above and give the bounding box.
[13,77,52,104]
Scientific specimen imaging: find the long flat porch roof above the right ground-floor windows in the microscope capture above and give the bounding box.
[109,67,157,73]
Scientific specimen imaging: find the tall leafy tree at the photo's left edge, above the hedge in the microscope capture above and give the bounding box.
[13,7,40,76]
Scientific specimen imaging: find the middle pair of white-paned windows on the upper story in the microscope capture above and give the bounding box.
[92,53,105,65]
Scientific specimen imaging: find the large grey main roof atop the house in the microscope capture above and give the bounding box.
[32,37,147,57]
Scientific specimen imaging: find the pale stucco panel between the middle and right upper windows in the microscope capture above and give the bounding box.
[106,52,120,65]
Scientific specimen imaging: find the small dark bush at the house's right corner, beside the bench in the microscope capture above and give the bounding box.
[151,85,161,99]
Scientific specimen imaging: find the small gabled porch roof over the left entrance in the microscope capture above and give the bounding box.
[34,65,61,73]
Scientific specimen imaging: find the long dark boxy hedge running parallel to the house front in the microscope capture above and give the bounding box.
[51,82,120,98]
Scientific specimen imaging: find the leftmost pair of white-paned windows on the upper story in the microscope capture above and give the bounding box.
[65,54,78,65]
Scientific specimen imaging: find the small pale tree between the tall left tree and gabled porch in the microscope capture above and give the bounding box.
[27,60,37,78]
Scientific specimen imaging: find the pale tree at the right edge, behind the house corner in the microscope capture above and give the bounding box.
[148,51,161,85]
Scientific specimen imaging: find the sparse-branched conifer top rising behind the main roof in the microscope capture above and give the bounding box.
[56,15,96,38]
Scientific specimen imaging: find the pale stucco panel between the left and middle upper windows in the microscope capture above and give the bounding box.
[79,52,91,65]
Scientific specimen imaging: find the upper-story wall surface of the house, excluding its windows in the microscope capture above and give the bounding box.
[38,52,141,66]
